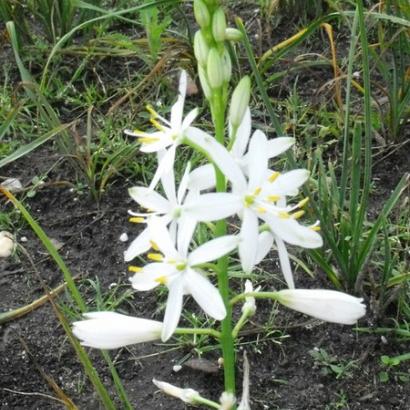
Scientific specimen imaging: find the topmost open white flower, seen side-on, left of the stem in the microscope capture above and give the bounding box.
[125,71,198,189]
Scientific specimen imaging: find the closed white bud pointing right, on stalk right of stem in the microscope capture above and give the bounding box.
[278,289,366,325]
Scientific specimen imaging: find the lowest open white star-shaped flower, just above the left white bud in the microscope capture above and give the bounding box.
[130,217,238,341]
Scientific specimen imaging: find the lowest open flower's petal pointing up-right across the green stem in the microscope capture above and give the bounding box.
[188,235,239,266]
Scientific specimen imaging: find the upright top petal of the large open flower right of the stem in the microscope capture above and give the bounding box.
[248,130,268,191]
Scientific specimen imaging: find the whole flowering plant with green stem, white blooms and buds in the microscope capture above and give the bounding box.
[73,0,365,410]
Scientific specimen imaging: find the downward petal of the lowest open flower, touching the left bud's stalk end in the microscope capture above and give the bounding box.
[161,278,184,342]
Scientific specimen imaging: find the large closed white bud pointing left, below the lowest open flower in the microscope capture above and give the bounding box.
[73,312,162,349]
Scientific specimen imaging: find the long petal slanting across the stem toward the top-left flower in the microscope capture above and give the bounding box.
[186,127,246,191]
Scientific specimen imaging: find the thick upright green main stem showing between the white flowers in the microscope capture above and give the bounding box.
[210,90,235,394]
